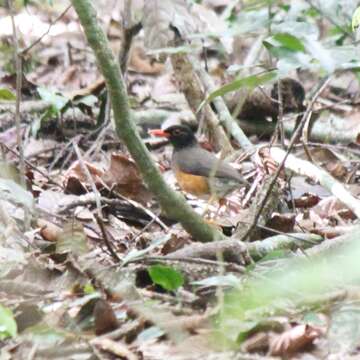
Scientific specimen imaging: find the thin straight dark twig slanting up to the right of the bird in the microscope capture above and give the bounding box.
[241,80,327,240]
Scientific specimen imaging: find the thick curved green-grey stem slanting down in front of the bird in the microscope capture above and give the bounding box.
[72,0,222,242]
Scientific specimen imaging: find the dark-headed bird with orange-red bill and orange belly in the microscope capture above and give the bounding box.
[150,124,249,203]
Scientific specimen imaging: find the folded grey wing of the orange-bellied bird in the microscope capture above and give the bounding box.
[173,147,246,183]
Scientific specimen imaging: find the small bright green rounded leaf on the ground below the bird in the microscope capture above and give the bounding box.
[148,264,184,291]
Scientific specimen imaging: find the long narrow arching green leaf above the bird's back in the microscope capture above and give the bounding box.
[198,70,277,111]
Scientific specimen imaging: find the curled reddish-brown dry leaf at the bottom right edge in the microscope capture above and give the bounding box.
[269,325,323,356]
